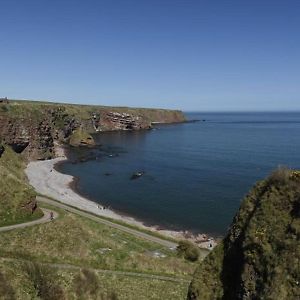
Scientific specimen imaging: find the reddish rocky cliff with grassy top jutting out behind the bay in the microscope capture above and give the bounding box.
[0,100,185,159]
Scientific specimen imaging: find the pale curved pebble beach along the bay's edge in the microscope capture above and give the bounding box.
[25,147,217,249]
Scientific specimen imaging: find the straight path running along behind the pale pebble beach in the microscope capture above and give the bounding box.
[37,196,177,249]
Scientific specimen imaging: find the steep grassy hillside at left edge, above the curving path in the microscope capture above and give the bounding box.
[0,146,42,226]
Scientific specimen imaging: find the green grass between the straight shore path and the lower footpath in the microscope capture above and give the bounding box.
[0,206,196,277]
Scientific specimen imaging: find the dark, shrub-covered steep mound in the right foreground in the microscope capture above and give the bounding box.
[188,169,300,300]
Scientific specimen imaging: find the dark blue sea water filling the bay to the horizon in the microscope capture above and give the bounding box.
[59,113,300,236]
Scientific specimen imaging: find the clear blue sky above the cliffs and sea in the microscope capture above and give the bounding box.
[0,0,300,111]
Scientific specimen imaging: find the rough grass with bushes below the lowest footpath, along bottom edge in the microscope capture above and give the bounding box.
[0,261,188,300]
